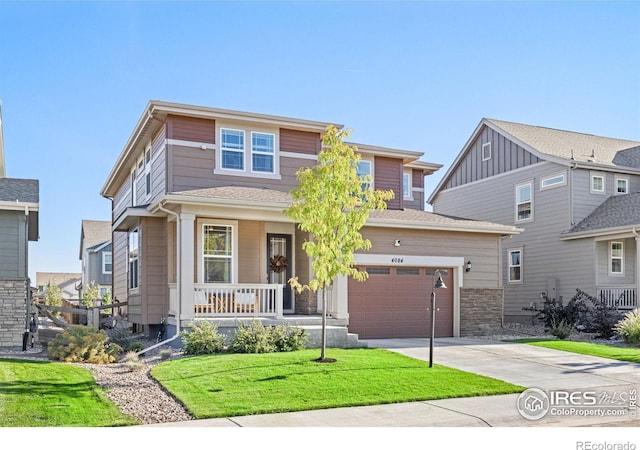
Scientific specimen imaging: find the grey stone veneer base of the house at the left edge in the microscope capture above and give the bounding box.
[0,278,28,350]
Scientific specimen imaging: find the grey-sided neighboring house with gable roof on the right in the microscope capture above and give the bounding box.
[428,119,640,321]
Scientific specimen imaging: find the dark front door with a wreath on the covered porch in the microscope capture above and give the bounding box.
[267,233,294,313]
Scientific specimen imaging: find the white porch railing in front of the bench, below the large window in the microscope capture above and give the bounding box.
[193,283,283,317]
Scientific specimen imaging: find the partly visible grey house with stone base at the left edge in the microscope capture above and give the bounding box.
[0,103,39,349]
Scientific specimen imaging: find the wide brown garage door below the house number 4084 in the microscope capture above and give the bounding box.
[348,266,453,339]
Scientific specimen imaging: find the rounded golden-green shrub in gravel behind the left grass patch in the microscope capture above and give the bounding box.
[48,325,123,364]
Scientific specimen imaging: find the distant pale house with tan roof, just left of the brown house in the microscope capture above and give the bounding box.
[79,220,113,298]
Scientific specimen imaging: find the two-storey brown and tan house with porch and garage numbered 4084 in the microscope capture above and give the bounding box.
[101,101,519,338]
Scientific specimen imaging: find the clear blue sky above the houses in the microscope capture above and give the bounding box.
[0,1,640,281]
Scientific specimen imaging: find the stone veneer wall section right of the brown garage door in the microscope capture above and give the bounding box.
[460,288,504,336]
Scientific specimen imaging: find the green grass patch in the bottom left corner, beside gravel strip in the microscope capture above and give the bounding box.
[0,359,140,427]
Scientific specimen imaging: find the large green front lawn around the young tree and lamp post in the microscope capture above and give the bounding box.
[151,349,525,419]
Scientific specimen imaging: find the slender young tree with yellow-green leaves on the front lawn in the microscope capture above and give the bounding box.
[285,125,394,361]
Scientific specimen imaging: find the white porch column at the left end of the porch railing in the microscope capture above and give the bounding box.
[177,213,196,320]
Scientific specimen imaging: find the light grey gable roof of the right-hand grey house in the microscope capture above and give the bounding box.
[427,118,640,203]
